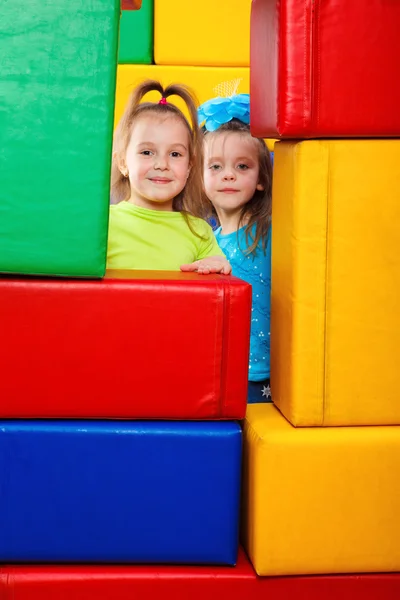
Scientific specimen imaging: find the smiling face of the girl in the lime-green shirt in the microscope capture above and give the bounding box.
[119,114,190,210]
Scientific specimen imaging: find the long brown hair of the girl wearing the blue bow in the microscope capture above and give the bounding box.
[203,119,272,254]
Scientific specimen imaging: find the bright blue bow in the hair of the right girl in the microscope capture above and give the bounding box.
[198,94,250,131]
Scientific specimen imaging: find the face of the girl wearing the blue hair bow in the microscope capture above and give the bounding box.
[204,131,263,216]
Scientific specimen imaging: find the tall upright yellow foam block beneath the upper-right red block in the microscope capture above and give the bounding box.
[271,140,400,426]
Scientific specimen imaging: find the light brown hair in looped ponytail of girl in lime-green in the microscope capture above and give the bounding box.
[111,80,207,225]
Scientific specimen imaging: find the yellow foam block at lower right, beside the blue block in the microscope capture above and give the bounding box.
[243,404,400,575]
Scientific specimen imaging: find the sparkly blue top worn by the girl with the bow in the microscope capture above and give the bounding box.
[215,226,271,401]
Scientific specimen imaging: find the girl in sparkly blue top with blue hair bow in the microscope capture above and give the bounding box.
[199,94,272,403]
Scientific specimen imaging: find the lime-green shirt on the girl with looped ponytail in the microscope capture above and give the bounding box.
[107,201,224,271]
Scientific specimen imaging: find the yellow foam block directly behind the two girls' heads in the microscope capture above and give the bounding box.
[115,65,275,151]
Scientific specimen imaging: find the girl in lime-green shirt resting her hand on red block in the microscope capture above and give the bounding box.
[107,81,231,274]
